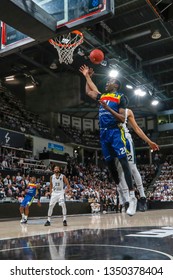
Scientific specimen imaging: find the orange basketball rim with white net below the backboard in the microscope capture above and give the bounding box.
[49,30,83,64]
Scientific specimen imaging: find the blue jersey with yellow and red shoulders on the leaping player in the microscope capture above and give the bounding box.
[99,92,124,128]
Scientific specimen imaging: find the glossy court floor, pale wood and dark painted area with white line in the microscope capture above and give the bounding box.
[0,209,173,260]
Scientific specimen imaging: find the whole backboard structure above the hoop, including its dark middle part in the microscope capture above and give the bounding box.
[0,0,114,56]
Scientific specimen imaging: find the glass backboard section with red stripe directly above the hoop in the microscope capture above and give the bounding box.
[33,0,114,29]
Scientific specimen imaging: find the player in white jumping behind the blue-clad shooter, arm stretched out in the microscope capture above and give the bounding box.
[99,100,159,211]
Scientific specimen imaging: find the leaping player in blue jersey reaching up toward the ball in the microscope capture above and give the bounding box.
[79,65,137,216]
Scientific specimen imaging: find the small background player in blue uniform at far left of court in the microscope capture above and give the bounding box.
[20,176,41,224]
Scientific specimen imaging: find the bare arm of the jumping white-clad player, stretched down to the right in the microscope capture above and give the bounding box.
[128,109,159,151]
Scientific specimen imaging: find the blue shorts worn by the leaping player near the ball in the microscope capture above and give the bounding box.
[100,128,127,161]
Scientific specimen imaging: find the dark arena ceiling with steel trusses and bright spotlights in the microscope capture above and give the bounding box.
[0,0,173,117]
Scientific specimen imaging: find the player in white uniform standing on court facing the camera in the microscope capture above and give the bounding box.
[45,166,70,226]
